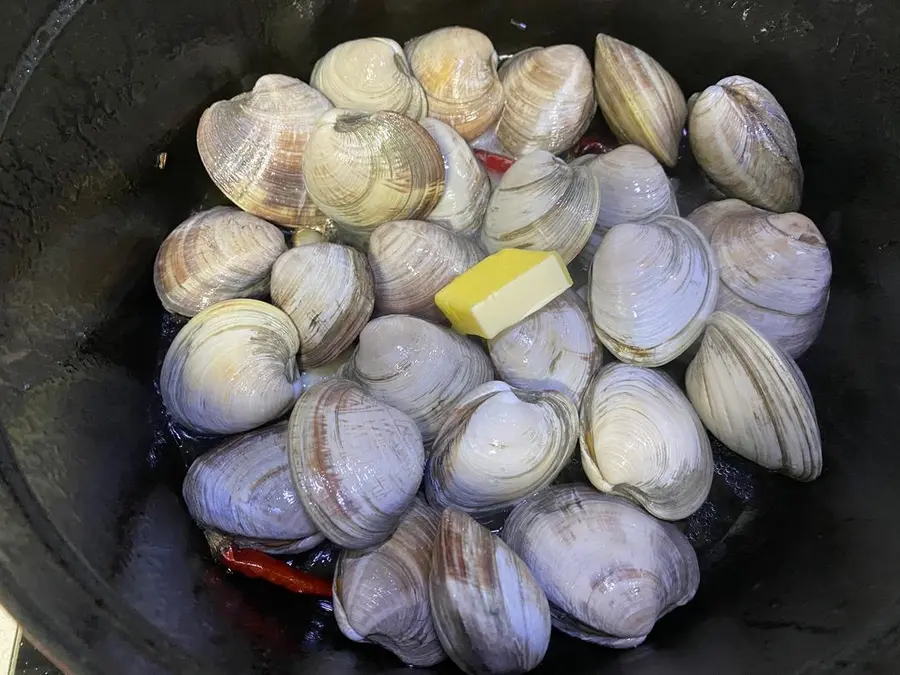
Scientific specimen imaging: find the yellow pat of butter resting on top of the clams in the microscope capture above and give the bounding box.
[434,248,572,339]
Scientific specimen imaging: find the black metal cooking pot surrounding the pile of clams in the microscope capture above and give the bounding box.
[0,0,900,675]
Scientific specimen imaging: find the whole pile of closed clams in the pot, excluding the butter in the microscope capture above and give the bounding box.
[154,27,831,673]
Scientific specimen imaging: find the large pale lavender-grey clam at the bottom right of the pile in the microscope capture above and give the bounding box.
[503,485,700,649]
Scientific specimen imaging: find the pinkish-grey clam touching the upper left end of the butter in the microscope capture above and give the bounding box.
[369,220,482,323]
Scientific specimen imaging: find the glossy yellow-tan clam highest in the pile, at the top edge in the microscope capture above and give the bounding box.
[405,26,503,141]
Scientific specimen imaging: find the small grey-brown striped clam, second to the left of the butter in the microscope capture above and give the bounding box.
[271,244,375,368]
